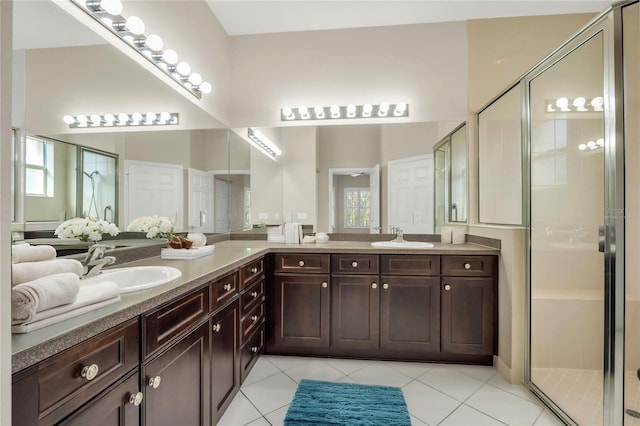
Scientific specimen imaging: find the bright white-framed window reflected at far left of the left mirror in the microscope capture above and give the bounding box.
[25,137,53,197]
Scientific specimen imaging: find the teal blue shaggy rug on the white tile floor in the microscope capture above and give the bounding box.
[284,379,411,426]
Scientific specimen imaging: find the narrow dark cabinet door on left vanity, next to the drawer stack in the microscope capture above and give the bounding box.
[210,299,240,424]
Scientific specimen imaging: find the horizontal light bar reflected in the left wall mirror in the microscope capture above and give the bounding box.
[63,111,180,129]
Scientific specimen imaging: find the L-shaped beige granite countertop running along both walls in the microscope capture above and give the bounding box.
[12,240,500,373]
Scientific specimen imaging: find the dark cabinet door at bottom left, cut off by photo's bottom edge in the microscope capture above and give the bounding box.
[61,370,144,426]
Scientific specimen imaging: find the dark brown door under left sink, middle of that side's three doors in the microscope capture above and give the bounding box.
[142,321,211,426]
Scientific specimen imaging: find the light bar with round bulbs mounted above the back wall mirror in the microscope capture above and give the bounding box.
[280,102,409,121]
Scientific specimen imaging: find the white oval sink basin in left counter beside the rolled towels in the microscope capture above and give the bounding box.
[84,266,182,293]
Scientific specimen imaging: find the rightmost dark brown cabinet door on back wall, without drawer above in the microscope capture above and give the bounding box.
[442,277,497,355]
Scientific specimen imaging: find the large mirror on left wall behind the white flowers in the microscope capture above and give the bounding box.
[12,2,242,238]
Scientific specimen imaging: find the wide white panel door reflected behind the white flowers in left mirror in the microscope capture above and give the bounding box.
[124,161,184,230]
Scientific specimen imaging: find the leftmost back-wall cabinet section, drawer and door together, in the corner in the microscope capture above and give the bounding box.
[270,254,331,348]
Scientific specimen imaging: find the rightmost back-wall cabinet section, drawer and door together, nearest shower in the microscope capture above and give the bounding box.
[441,256,498,356]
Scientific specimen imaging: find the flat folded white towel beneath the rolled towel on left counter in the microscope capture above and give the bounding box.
[12,281,120,333]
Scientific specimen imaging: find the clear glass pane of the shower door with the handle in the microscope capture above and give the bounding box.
[529,33,604,425]
